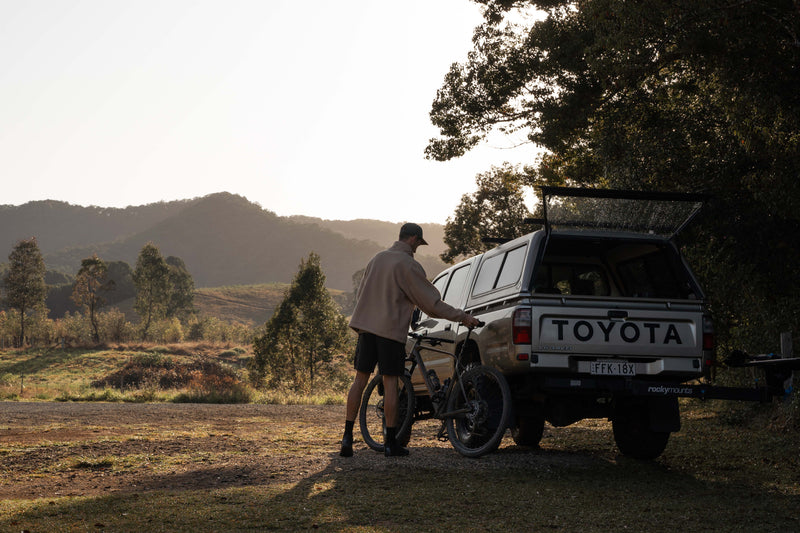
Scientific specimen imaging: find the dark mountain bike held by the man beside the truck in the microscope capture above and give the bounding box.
[359,328,511,457]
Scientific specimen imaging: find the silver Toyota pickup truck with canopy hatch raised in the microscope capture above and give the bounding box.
[412,187,714,458]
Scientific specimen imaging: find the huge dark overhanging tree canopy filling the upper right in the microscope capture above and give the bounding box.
[427,0,800,356]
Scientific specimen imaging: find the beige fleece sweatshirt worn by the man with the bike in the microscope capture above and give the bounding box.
[350,241,466,343]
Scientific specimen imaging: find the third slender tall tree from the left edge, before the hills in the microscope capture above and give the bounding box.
[133,242,169,339]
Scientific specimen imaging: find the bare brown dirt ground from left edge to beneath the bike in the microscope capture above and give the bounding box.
[0,402,591,499]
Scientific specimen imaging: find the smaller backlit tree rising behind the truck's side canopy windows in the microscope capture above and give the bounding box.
[441,164,531,263]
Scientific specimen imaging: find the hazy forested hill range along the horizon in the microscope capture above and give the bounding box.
[0,193,445,291]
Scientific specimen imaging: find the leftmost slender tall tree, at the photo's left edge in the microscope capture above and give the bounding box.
[3,237,47,346]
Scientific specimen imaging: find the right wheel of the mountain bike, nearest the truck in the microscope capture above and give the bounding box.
[447,366,511,457]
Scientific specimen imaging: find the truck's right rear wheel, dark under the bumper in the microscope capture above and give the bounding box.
[611,403,670,459]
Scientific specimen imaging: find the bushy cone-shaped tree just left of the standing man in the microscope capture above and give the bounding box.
[254,252,349,388]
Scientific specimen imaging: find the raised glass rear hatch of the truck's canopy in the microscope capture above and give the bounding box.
[541,187,707,238]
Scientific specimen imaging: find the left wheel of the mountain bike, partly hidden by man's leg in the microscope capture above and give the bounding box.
[358,374,414,452]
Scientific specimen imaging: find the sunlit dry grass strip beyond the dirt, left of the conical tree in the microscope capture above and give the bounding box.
[0,343,256,402]
